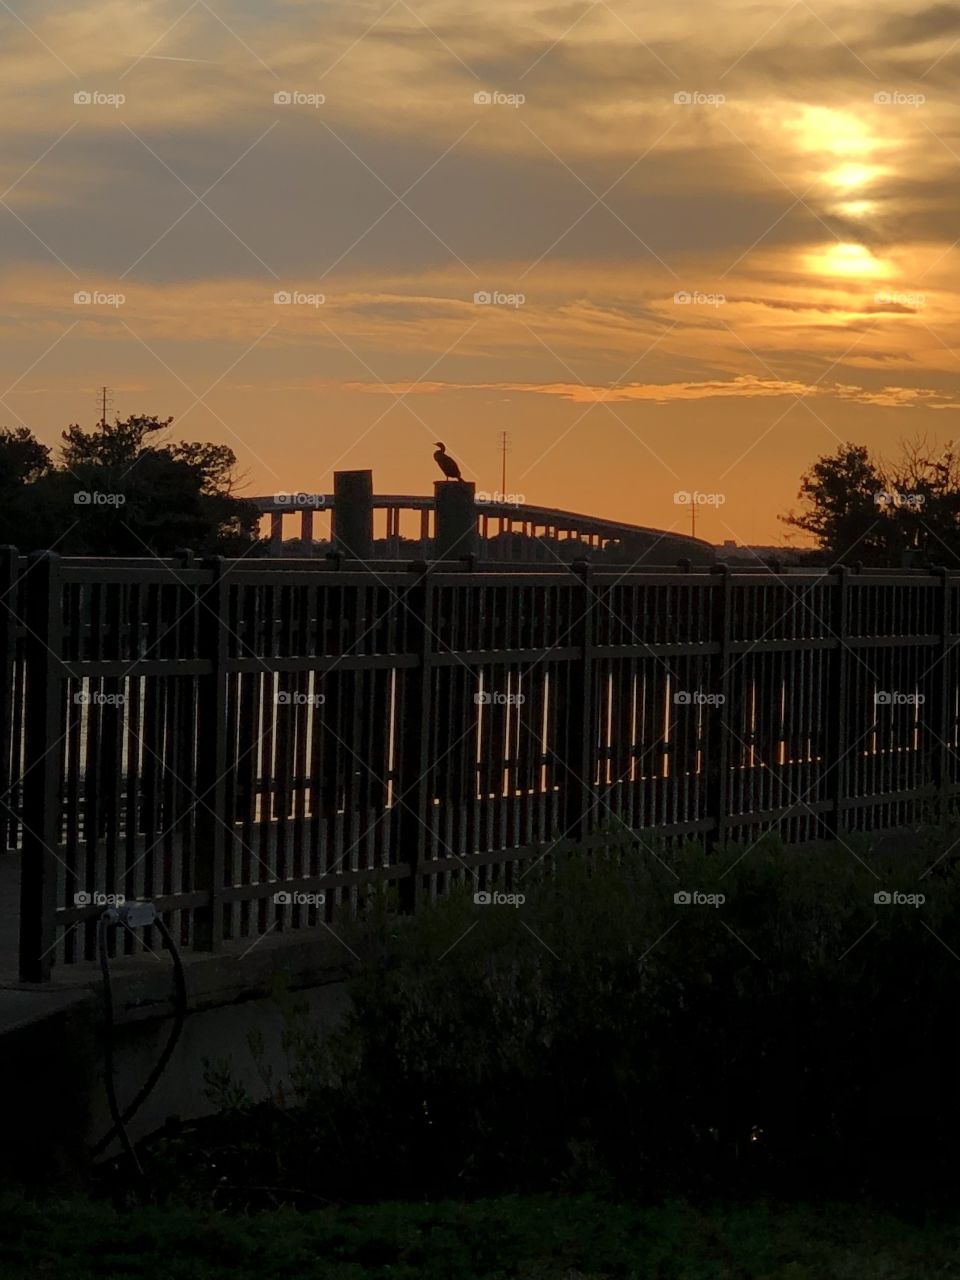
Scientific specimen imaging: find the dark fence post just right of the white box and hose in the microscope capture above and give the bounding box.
[193,556,233,951]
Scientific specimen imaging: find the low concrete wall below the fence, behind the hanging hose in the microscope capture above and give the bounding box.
[0,934,358,1189]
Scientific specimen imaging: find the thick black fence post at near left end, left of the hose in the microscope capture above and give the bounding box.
[20,552,63,982]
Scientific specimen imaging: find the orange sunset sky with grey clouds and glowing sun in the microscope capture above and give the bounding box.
[0,0,960,543]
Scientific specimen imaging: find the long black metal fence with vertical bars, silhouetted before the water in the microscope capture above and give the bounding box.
[0,552,960,980]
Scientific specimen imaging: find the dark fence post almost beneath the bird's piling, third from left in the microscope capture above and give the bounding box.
[390,561,435,913]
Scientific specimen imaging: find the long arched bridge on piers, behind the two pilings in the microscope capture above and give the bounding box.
[247,471,716,564]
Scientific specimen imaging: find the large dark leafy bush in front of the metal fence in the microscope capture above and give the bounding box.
[144,840,960,1201]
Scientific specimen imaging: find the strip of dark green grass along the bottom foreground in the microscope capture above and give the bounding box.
[0,1196,960,1280]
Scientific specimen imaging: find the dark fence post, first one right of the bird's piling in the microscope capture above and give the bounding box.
[559,561,596,841]
